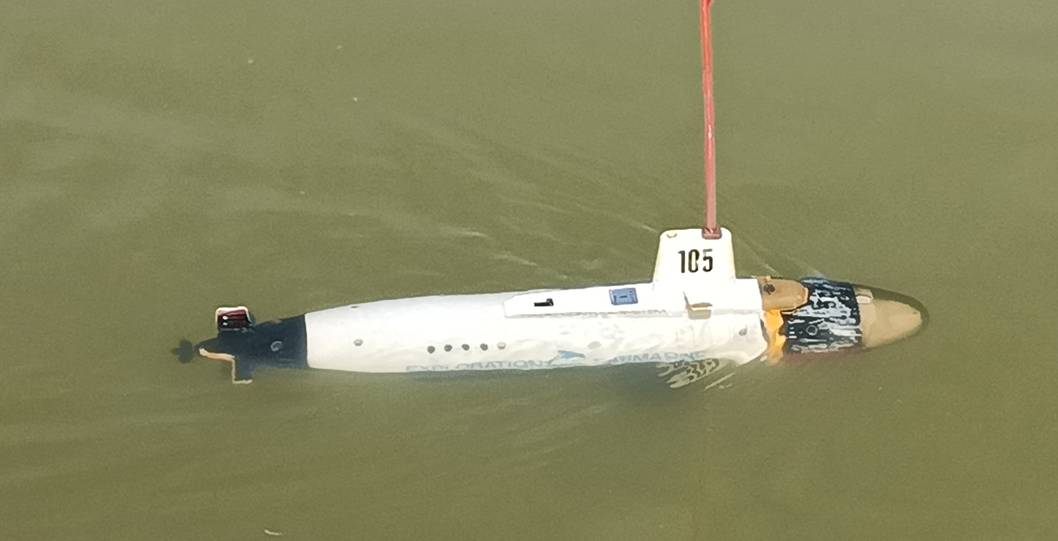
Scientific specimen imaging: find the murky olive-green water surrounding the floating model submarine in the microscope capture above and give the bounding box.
[0,0,1058,539]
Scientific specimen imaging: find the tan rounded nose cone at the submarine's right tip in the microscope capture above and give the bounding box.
[856,287,927,347]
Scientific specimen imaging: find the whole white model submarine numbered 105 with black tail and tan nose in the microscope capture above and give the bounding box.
[188,229,926,387]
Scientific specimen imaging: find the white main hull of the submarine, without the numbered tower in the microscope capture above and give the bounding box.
[305,279,767,373]
